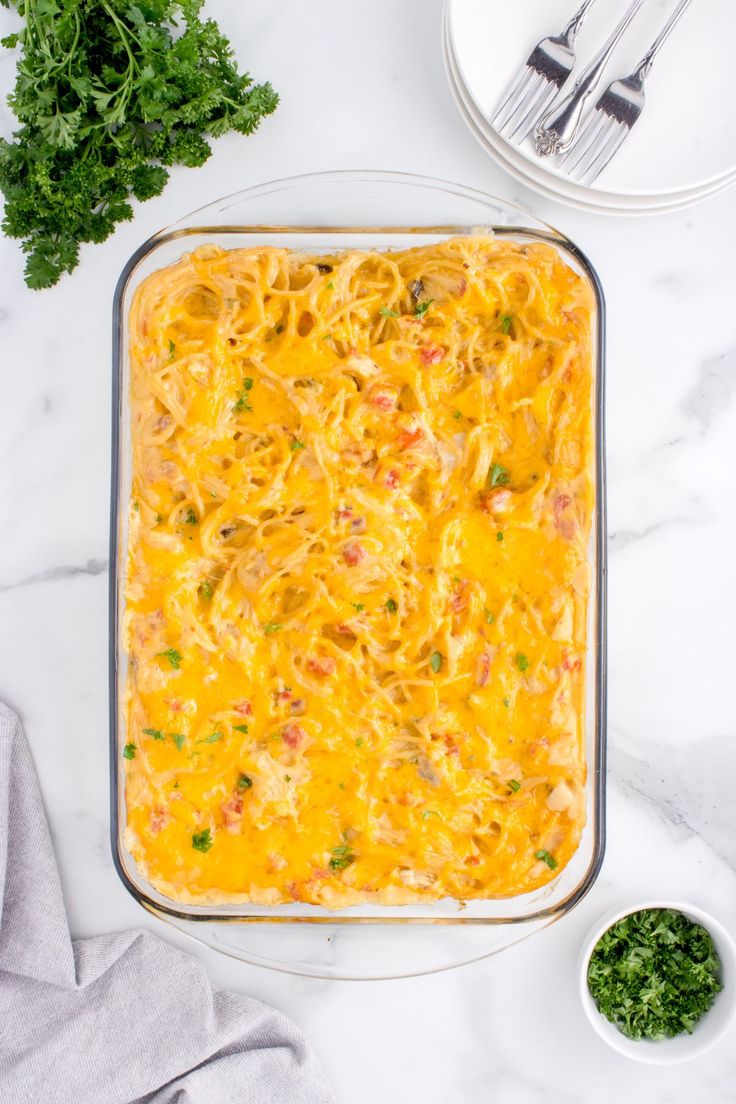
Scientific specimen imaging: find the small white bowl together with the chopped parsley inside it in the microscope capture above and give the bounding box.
[579,902,736,1064]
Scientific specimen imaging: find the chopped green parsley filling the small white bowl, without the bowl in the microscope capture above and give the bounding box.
[588,909,723,1039]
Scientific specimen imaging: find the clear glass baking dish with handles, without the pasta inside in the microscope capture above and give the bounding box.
[109,172,606,976]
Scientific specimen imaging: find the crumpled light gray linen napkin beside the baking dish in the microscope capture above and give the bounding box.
[0,703,334,1104]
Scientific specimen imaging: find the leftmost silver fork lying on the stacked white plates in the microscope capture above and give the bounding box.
[491,0,595,141]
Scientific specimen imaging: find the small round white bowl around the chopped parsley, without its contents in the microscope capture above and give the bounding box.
[578,901,736,1065]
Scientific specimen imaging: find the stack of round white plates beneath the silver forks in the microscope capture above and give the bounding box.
[442,0,736,214]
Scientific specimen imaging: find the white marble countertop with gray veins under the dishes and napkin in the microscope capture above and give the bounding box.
[0,0,736,1104]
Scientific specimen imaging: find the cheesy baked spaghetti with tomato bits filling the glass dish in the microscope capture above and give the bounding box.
[124,235,594,907]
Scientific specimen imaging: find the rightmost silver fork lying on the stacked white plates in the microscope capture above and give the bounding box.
[559,0,692,184]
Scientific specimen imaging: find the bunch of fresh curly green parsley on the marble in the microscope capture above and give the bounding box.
[0,0,278,288]
